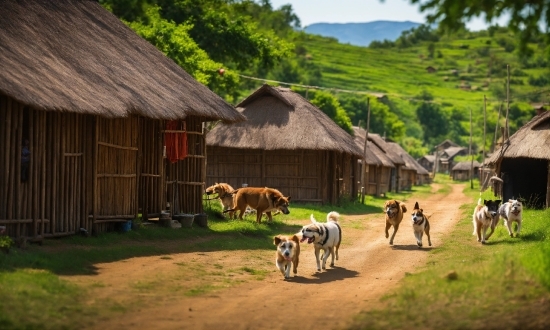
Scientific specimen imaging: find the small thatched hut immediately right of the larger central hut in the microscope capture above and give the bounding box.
[353,127,395,196]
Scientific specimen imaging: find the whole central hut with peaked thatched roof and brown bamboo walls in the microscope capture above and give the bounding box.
[206,84,363,204]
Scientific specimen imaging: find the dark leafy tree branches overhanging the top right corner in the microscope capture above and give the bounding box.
[410,0,550,51]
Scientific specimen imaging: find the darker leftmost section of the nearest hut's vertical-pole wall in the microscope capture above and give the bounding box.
[0,96,95,240]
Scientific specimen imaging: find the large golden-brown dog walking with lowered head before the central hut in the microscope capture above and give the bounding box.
[224,187,290,223]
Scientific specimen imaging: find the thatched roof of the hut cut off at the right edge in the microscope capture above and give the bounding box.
[485,111,550,166]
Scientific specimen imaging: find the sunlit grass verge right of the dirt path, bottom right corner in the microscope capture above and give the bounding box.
[350,181,550,329]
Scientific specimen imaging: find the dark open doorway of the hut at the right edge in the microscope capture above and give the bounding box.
[501,158,548,208]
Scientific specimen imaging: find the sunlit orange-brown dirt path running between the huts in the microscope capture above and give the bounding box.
[70,185,471,330]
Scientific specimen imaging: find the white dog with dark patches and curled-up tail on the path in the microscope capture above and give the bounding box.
[300,211,342,271]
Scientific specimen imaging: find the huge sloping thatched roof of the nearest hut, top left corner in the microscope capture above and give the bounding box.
[0,0,244,122]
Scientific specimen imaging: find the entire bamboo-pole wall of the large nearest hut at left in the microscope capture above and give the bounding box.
[0,95,206,241]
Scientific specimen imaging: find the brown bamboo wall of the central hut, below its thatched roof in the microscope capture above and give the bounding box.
[206,147,357,203]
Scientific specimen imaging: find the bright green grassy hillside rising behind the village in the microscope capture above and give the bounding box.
[295,29,549,152]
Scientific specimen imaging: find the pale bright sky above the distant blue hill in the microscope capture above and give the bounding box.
[271,0,506,31]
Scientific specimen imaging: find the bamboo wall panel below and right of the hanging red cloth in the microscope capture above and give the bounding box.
[165,117,206,213]
